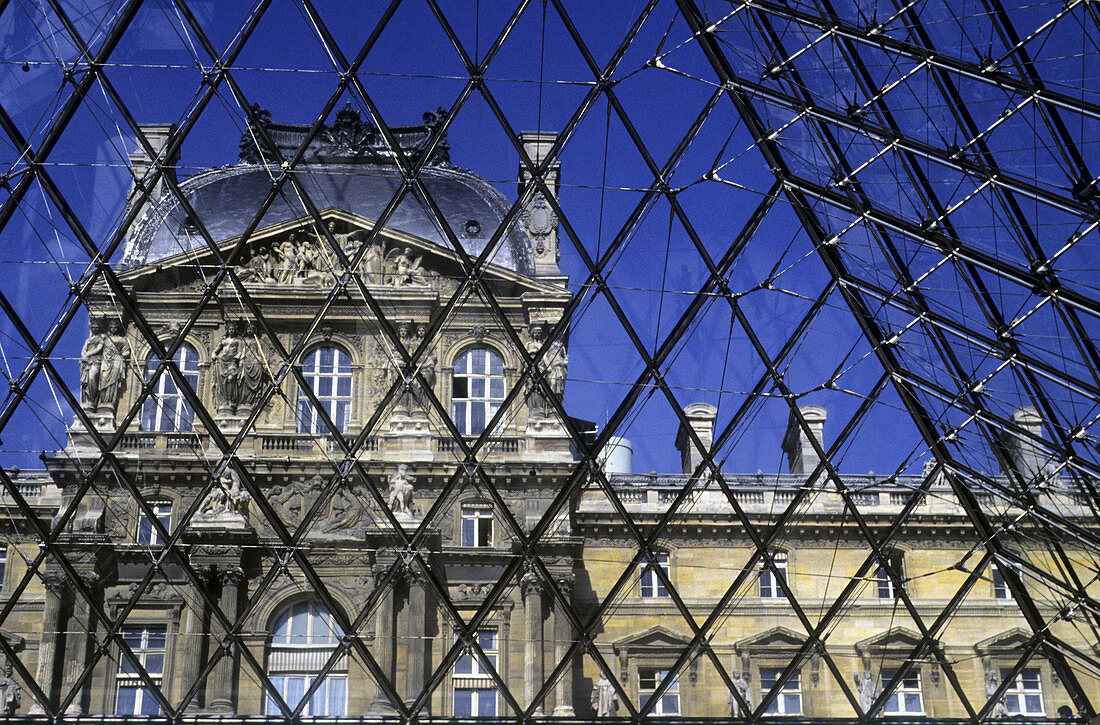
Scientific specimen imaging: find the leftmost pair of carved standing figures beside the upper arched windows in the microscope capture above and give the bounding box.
[80,318,130,419]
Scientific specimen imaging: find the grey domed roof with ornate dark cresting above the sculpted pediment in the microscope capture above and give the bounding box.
[121,110,534,274]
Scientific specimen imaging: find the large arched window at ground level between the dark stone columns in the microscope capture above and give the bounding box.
[267,602,348,717]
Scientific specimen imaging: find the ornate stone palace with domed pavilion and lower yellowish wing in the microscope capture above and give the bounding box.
[0,109,1100,718]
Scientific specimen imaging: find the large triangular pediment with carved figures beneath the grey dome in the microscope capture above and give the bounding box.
[121,209,563,297]
